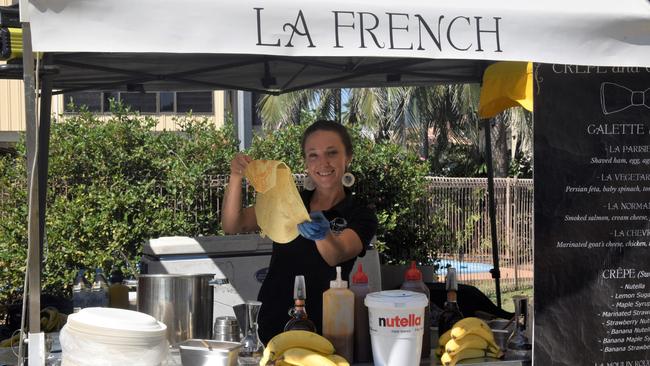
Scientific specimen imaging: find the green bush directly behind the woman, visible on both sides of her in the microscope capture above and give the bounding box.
[250,124,445,263]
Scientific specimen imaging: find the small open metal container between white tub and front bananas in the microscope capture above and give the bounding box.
[178,339,241,366]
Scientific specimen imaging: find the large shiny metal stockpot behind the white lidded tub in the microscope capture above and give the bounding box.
[138,274,214,346]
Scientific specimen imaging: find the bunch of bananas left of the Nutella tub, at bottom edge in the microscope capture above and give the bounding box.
[260,330,350,366]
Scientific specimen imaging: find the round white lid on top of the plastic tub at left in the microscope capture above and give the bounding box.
[66,308,167,340]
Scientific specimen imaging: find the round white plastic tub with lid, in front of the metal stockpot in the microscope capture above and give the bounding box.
[59,308,169,366]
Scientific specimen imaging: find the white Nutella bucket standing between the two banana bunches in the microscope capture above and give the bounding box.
[364,290,428,366]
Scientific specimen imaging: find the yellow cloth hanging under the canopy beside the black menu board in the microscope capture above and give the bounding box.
[478,61,533,118]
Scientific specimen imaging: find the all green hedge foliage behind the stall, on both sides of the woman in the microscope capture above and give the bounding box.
[0,111,444,303]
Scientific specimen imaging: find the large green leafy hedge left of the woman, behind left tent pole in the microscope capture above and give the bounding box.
[0,105,237,302]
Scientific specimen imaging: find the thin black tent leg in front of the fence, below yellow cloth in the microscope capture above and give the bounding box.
[483,119,501,307]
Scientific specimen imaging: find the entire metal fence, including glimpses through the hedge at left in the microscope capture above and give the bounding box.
[0,174,533,294]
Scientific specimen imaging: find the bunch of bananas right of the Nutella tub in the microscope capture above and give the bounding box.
[436,317,503,366]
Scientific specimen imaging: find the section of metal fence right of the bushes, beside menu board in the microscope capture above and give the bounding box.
[427,177,533,294]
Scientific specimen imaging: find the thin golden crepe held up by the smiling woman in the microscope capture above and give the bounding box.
[244,160,309,243]
